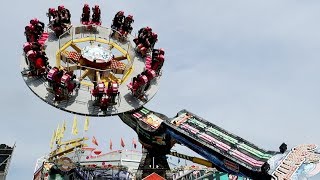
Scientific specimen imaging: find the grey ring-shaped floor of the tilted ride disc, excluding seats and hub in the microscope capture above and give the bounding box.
[20,26,159,116]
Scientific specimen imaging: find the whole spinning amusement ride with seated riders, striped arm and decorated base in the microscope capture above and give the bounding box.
[21,4,320,180]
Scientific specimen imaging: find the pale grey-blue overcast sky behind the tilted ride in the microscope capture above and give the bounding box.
[0,0,320,180]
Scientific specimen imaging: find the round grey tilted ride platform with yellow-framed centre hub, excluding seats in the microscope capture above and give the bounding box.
[20,26,160,116]
